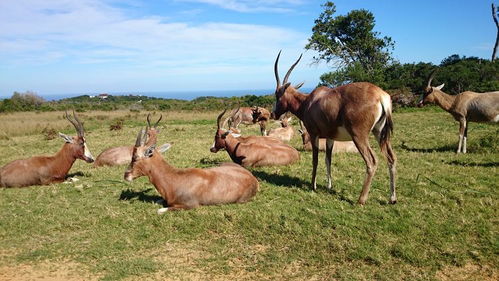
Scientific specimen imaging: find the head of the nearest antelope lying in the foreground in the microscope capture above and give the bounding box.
[124,127,171,181]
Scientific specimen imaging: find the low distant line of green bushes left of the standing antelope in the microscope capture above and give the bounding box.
[0,89,274,112]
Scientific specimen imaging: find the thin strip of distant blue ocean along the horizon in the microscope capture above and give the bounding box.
[37,89,310,101]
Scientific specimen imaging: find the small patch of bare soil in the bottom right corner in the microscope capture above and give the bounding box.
[435,263,499,281]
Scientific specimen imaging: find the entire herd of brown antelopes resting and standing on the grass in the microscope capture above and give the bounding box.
[0,52,499,210]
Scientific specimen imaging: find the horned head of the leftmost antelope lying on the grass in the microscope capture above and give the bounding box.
[59,110,94,163]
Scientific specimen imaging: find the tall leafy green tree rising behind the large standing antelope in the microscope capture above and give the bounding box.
[305,1,394,86]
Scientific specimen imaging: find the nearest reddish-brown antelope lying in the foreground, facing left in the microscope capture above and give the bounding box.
[124,127,259,214]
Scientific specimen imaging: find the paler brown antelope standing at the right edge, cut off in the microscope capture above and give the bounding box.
[418,71,499,153]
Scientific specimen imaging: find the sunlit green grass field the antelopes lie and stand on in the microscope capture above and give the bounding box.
[0,108,499,280]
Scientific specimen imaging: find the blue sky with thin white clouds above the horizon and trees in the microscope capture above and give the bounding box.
[0,0,499,97]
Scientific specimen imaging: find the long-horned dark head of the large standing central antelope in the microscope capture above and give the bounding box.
[272,51,303,120]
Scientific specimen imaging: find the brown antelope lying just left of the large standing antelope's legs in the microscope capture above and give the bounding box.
[210,110,300,167]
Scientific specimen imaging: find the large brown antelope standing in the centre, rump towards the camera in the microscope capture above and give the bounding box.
[273,52,397,205]
